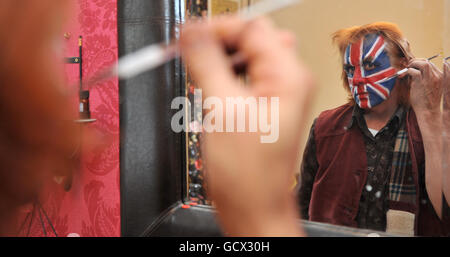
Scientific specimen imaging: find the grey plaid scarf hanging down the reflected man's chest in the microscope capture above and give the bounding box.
[389,121,416,205]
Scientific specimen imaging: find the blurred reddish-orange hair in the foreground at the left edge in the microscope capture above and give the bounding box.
[0,0,79,215]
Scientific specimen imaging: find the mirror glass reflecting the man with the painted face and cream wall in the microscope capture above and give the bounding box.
[186,0,450,236]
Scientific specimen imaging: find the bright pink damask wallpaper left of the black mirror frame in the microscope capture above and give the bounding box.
[22,0,120,237]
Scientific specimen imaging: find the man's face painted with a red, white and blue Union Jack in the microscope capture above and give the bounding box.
[344,34,397,109]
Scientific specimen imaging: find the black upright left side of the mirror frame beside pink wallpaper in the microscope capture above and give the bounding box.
[118,0,185,236]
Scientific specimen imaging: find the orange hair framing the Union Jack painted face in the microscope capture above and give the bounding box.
[332,22,414,105]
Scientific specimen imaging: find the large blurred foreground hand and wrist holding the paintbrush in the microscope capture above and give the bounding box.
[181,17,313,236]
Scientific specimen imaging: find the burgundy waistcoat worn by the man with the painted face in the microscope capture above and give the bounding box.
[309,104,450,236]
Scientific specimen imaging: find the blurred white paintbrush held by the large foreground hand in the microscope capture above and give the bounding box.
[84,0,301,88]
